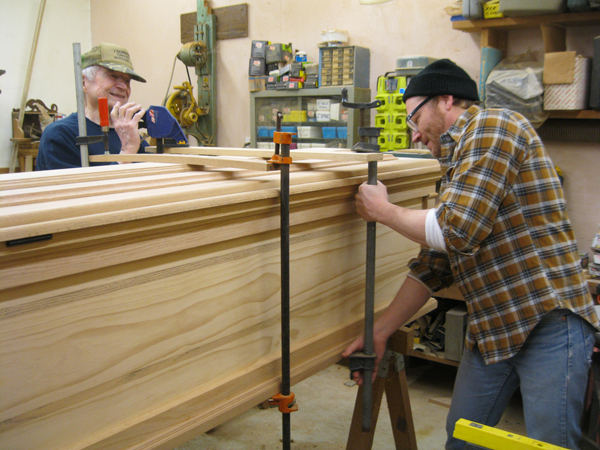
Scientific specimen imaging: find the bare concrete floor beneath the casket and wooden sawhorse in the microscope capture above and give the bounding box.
[176,358,525,450]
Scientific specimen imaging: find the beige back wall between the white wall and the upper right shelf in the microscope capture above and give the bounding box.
[91,0,479,147]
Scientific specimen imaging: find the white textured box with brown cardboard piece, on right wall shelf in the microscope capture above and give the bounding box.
[544,52,591,110]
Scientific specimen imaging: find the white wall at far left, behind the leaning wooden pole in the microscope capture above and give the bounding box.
[0,0,92,170]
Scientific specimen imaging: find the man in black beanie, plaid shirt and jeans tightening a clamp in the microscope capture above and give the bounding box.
[344,59,598,450]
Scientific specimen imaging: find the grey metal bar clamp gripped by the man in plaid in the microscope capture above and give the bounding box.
[342,88,381,432]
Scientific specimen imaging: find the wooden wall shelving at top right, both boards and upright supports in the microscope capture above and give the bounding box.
[452,11,600,119]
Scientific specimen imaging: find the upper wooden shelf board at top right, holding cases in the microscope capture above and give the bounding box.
[452,11,600,33]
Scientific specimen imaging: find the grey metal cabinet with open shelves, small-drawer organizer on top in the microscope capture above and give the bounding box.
[250,86,371,148]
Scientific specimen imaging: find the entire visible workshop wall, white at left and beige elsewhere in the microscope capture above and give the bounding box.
[0,0,600,255]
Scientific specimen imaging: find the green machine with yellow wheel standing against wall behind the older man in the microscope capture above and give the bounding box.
[164,0,217,147]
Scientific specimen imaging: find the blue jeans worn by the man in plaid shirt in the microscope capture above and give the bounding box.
[446,309,594,450]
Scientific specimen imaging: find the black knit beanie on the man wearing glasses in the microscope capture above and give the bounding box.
[402,59,479,102]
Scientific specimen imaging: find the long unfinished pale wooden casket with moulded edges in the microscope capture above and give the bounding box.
[0,158,440,450]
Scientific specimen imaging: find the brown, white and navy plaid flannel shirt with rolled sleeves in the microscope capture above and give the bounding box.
[409,106,598,364]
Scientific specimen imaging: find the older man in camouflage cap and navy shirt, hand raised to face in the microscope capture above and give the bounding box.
[36,43,147,170]
